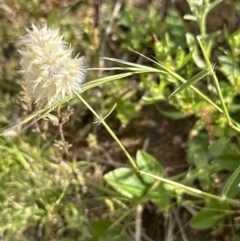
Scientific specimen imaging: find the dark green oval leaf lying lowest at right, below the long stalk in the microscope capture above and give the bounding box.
[190,210,225,229]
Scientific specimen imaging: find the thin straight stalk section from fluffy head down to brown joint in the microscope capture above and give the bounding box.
[74,91,139,172]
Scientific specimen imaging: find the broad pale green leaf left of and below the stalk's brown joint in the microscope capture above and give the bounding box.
[104,167,147,199]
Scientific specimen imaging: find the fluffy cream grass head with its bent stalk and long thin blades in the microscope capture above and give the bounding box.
[2,25,240,211]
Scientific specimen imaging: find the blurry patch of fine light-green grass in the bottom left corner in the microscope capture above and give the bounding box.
[0,142,88,240]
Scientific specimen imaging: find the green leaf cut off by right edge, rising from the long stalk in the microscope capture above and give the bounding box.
[222,166,240,198]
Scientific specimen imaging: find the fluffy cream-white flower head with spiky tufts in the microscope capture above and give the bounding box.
[19,25,86,105]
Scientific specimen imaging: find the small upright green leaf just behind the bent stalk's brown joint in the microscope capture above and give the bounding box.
[136,150,163,185]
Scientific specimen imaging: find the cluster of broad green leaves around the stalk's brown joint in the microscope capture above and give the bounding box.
[104,151,173,208]
